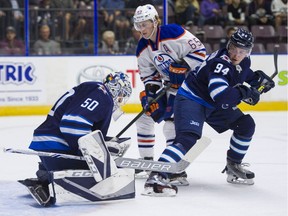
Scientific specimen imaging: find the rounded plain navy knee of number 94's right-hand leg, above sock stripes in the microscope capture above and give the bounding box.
[231,114,255,137]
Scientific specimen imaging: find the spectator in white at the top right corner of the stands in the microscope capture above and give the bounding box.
[271,0,288,31]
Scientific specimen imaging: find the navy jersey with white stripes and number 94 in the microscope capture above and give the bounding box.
[178,48,256,109]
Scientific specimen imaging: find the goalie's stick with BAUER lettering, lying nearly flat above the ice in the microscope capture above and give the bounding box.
[3,136,211,173]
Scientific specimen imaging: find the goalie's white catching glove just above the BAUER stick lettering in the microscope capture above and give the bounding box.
[105,137,131,157]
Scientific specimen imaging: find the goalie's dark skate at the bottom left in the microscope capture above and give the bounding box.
[18,178,55,207]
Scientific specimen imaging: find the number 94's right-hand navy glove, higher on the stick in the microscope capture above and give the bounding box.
[251,70,275,93]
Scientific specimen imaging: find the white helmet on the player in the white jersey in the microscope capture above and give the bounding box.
[133,4,158,23]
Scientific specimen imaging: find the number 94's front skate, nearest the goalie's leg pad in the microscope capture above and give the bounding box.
[142,172,178,197]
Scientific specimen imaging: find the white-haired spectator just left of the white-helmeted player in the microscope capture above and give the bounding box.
[98,30,120,55]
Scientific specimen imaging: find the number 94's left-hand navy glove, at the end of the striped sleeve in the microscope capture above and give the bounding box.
[237,85,260,106]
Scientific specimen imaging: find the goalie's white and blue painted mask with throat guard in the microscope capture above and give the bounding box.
[104,72,132,121]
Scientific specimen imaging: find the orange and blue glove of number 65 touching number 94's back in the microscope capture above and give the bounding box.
[169,63,189,89]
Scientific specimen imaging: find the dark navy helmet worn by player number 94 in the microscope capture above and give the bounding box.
[227,28,254,50]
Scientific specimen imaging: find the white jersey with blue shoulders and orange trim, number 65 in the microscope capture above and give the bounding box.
[136,24,206,86]
